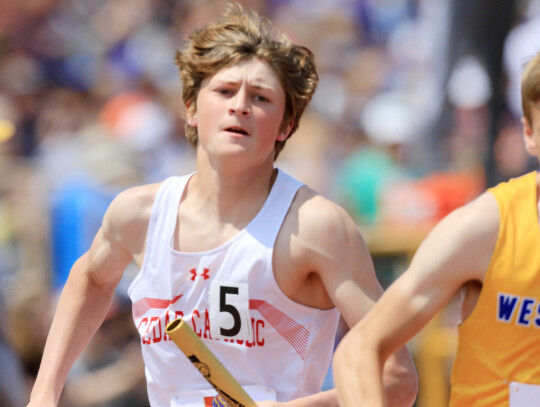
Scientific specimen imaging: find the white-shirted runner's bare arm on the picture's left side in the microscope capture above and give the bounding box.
[28,187,150,407]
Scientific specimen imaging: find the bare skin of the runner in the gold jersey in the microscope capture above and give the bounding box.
[333,103,540,407]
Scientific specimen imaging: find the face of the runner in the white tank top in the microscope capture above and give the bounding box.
[188,58,290,166]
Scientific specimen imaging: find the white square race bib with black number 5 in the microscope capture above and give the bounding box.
[209,281,253,341]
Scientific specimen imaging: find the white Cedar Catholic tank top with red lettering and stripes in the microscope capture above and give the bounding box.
[128,171,339,407]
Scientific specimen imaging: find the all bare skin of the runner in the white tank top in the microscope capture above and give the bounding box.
[29,59,416,407]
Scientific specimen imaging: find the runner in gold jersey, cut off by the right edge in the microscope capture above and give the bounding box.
[334,53,540,407]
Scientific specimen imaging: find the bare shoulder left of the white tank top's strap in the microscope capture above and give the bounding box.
[103,183,161,254]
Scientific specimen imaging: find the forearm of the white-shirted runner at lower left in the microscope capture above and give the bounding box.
[31,256,115,405]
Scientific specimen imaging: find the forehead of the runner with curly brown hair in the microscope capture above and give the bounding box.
[207,58,283,92]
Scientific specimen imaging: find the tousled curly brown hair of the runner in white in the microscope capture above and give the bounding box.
[175,3,319,159]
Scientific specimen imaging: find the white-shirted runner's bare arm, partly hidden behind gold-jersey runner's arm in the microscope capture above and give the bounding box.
[281,191,417,407]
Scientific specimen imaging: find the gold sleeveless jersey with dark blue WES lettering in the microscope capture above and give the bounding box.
[450,172,540,407]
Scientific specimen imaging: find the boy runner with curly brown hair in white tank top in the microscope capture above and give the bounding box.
[25,6,416,407]
